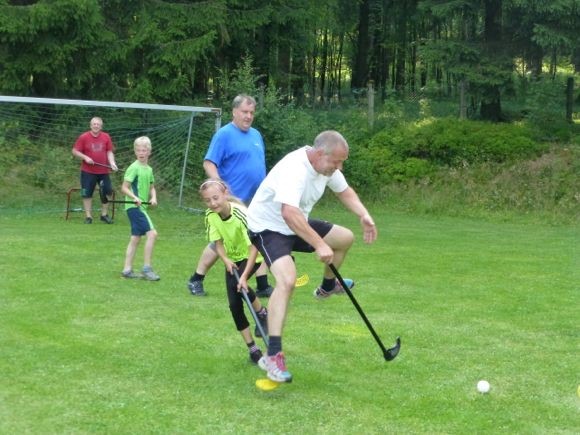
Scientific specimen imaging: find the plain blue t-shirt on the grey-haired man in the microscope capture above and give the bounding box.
[205,122,266,203]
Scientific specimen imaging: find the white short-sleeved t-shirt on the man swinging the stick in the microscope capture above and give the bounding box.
[247,146,348,235]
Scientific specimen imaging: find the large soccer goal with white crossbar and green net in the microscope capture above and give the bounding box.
[0,96,221,208]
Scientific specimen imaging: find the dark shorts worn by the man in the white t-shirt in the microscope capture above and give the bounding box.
[249,219,333,267]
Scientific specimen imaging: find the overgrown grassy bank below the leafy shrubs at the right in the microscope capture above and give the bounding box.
[379,146,580,222]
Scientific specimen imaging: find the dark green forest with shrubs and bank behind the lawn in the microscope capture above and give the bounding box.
[0,0,580,220]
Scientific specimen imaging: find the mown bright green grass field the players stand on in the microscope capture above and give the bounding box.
[0,207,580,434]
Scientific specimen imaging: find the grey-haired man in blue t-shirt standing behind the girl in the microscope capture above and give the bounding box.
[187,94,273,297]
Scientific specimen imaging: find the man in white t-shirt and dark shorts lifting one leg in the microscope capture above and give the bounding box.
[247,130,377,382]
